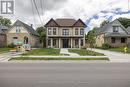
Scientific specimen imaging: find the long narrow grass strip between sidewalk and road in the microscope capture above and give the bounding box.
[10,57,109,61]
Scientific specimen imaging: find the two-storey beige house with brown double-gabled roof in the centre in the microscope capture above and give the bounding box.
[45,19,86,48]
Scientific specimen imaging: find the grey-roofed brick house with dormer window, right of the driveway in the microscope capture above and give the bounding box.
[96,19,130,47]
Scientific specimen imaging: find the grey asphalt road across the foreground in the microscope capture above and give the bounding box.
[0,63,130,87]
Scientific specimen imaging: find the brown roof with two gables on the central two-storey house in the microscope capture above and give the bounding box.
[45,18,86,27]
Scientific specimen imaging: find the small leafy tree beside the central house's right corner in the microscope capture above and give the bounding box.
[85,27,97,47]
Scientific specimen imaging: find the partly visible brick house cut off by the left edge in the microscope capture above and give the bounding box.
[0,25,8,47]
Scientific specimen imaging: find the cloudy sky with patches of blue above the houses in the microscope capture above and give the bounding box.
[2,0,130,31]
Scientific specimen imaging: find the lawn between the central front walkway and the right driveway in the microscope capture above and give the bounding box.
[69,49,104,56]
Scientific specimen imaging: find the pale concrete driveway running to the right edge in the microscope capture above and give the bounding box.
[88,48,130,62]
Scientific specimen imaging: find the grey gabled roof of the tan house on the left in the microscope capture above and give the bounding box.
[12,20,39,36]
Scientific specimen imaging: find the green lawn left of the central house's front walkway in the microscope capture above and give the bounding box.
[22,48,60,56]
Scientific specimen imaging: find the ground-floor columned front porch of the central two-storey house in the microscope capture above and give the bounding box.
[47,38,85,48]
